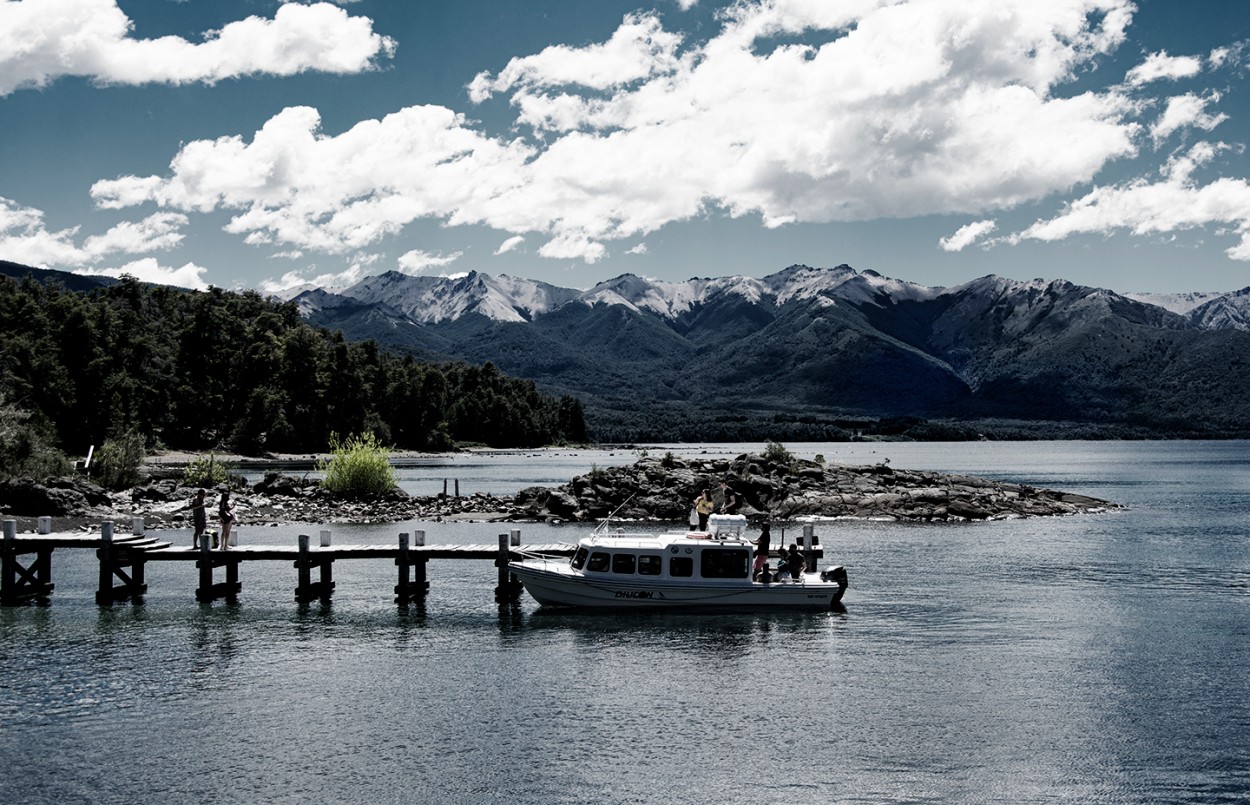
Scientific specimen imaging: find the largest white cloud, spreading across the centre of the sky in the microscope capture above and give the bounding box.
[93,0,1250,263]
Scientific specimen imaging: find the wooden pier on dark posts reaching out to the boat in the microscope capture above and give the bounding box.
[0,518,576,606]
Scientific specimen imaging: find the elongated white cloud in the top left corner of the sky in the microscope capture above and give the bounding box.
[0,0,395,96]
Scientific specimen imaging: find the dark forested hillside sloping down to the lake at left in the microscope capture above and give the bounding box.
[0,276,586,455]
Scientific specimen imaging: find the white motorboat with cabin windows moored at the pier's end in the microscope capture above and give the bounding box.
[508,515,848,609]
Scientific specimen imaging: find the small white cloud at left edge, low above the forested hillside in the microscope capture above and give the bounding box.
[0,198,188,268]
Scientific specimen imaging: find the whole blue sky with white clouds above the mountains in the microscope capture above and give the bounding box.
[0,0,1250,293]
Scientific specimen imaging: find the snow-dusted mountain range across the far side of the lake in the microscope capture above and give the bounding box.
[293,265,1250,438]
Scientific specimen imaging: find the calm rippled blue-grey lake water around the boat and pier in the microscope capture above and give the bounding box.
[0,441,1250,803]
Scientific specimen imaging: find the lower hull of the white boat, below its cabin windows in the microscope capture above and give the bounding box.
[509,563,845,609]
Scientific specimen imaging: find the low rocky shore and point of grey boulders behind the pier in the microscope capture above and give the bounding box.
[0,454,1121,530]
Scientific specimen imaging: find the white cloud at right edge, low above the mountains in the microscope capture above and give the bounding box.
[1005,143,1250,260]
